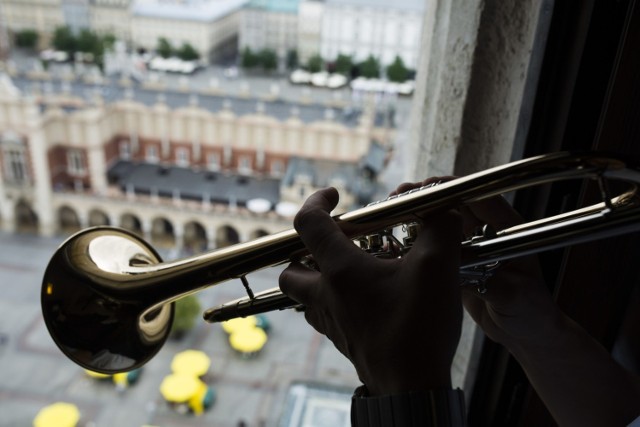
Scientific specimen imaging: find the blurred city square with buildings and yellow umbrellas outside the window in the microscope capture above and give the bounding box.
[0,0,438,426]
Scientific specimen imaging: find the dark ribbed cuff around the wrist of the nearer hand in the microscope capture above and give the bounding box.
[351,386,466,427]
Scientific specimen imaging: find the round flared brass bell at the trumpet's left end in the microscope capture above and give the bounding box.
[41,227,174,374]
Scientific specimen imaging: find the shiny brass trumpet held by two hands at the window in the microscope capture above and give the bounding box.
[41,152,640,374]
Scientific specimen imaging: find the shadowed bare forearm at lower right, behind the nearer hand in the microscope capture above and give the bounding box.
[505,310,640,427]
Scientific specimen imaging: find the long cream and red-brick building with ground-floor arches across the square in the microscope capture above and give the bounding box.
[0,73,390,249]
